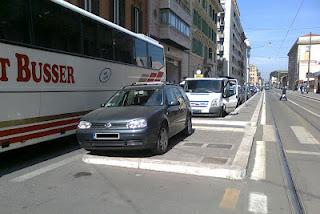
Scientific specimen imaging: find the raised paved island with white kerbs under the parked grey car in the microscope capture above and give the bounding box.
[82,93,262,179]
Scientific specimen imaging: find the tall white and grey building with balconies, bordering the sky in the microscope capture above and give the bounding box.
[217,0,247,84]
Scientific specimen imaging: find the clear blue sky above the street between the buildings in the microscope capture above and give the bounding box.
[237,0,320,80]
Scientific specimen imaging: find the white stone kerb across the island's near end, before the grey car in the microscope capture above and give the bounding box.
[82,155,246,180]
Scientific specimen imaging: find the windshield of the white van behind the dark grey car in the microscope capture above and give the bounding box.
[185,80,222,93]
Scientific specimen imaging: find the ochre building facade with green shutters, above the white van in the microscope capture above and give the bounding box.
[189,0,222,77]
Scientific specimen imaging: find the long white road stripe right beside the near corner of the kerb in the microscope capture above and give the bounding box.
[251,141,266,181]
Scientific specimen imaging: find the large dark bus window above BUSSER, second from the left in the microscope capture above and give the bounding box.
[31,0,82,54]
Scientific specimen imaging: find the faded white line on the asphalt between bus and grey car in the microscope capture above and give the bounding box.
[10,155,82,183]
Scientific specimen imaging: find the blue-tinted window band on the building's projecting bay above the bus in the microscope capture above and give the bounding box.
[160,9,190,36]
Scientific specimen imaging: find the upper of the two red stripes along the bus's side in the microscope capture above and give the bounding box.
[0,118,80,137]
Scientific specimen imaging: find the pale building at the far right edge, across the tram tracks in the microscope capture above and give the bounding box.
[288,34,320,92]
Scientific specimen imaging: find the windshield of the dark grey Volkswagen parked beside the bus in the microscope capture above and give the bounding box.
[106,89,163,107]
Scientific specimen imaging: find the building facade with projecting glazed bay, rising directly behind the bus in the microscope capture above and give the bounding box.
[148,0,192,83]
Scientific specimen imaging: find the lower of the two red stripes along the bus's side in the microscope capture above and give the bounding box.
[0,125,77,145]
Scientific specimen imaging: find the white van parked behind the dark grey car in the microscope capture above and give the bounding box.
[183,77,238,116]
